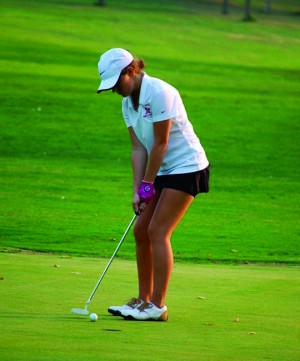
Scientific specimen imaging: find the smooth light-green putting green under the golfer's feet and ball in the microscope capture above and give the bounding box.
[0,253,300,361]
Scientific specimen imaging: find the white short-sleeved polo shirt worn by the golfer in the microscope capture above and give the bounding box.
[122,73,208,175]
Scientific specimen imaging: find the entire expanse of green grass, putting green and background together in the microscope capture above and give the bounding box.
[0,0,300,361]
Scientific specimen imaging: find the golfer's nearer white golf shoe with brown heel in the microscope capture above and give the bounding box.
[121,302,169,321]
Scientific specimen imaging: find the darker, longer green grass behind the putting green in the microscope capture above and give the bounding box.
[0,0,300,264]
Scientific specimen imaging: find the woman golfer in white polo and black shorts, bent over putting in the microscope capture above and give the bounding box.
[98,48,209,321]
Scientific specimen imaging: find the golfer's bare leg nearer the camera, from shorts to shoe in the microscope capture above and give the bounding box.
[148,189,194,307]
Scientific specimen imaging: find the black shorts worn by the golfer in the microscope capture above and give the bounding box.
[154,166,209,197]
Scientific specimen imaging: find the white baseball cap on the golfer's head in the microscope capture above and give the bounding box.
[97,48,133,93]
